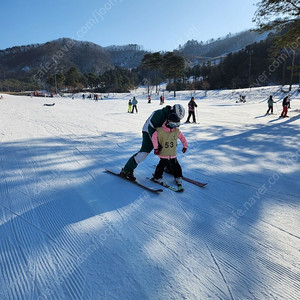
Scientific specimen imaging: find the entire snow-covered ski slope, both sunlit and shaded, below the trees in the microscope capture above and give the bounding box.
[0,87,300,300]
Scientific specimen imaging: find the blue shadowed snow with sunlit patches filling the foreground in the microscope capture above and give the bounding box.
[0,118,300,299]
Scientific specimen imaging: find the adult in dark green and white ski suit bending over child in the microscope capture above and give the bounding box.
[120,104,185,181]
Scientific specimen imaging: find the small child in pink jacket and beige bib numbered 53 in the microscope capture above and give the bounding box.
[152,113,188,188]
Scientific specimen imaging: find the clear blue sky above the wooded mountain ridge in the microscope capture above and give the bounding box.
[0,0,260,51]
